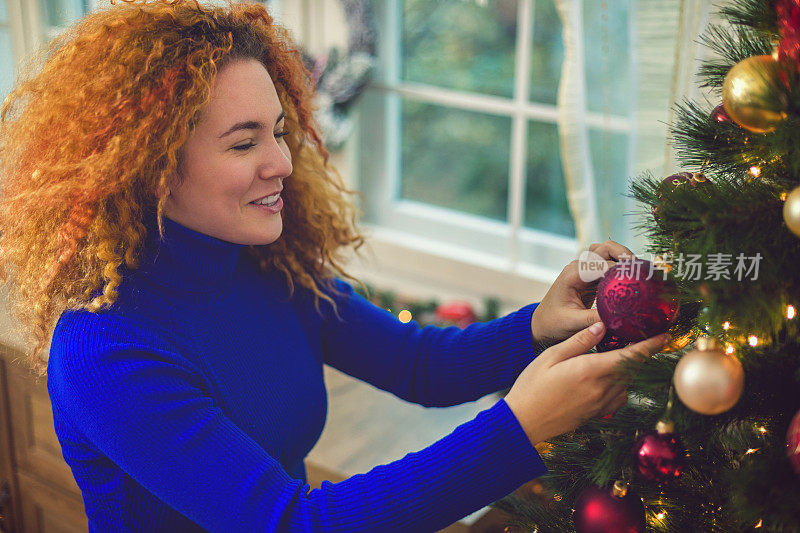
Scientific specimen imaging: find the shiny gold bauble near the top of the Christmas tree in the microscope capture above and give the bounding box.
[722,55,788,133]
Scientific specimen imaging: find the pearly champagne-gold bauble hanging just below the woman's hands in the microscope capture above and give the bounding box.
[672,337,744,415]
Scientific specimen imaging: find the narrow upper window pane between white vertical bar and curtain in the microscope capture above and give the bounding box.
[530,0,564,104]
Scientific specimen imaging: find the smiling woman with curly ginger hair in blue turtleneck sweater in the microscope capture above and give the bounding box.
[0,0,665,532]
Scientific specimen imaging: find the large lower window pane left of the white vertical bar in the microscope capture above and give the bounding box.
[400,100,511,221]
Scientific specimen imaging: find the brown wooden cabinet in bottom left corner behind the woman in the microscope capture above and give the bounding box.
[0,344,89,533]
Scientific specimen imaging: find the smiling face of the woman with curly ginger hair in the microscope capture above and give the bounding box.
[165,59,292,244]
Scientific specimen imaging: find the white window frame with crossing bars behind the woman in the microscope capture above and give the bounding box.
[346,0,635,301]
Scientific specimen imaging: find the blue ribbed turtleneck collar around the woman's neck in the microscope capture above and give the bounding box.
[137,214,245,292]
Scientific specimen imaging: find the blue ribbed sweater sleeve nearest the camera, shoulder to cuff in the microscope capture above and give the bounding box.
[48,326,545,532]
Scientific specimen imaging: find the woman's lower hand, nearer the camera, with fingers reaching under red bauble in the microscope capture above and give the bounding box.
[505,322,669,445]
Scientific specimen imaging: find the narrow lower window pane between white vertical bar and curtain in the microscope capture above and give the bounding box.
[524,122,575,237]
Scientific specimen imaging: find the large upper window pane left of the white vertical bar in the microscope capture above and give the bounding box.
[401,0,517,97]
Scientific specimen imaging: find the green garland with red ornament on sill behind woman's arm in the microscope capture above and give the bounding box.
[354,283,500,328]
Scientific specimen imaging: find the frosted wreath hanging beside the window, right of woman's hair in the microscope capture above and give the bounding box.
[303,0,378,151]
